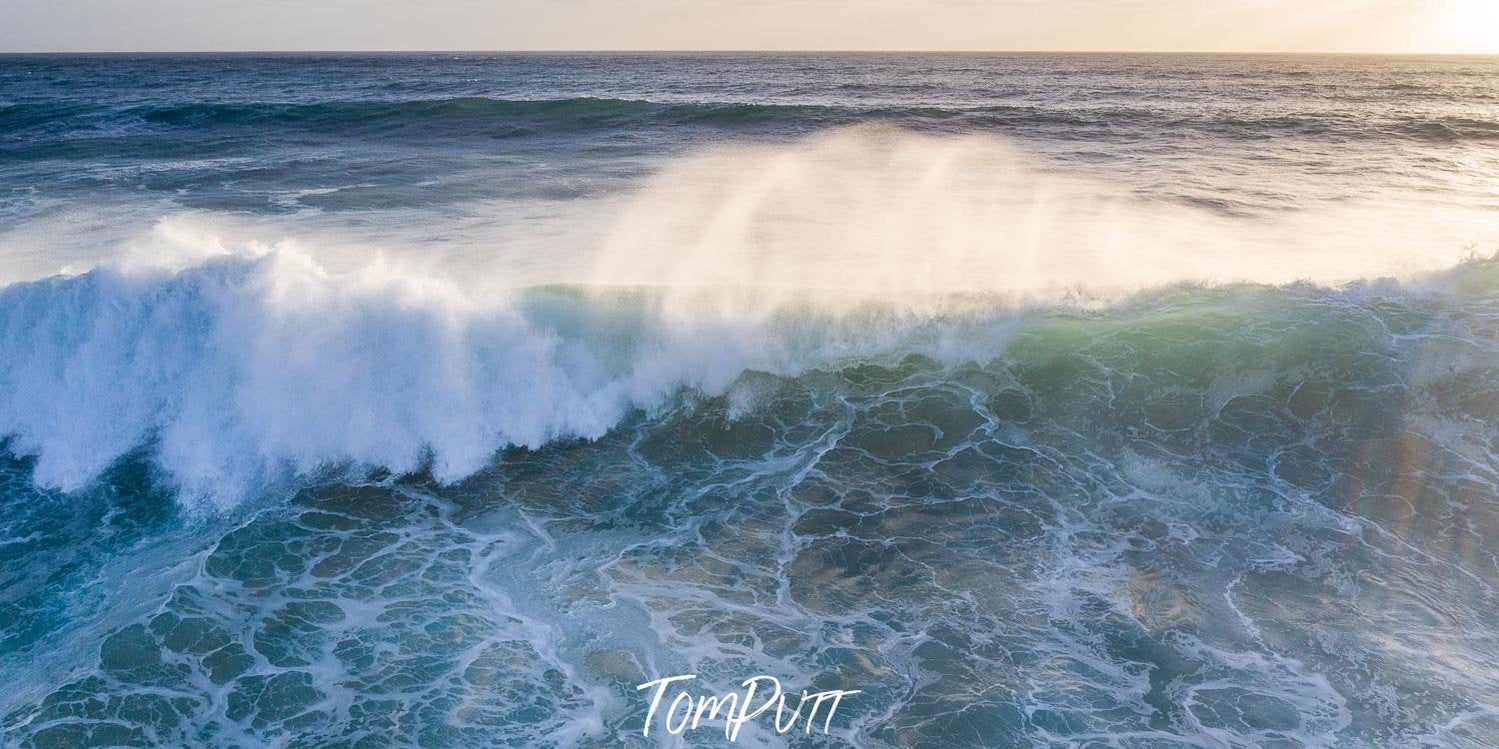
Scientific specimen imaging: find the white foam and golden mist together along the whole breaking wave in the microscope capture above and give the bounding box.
[0,127,1496,505]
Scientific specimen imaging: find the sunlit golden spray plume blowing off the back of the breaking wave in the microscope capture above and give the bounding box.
[588,127,1499,293]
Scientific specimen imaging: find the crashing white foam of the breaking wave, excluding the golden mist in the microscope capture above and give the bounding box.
[0,250,1031,503]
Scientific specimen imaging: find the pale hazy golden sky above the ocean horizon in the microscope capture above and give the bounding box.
[0,0,1499,52]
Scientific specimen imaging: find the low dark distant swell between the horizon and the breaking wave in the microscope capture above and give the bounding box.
[0,96,1499,142]
